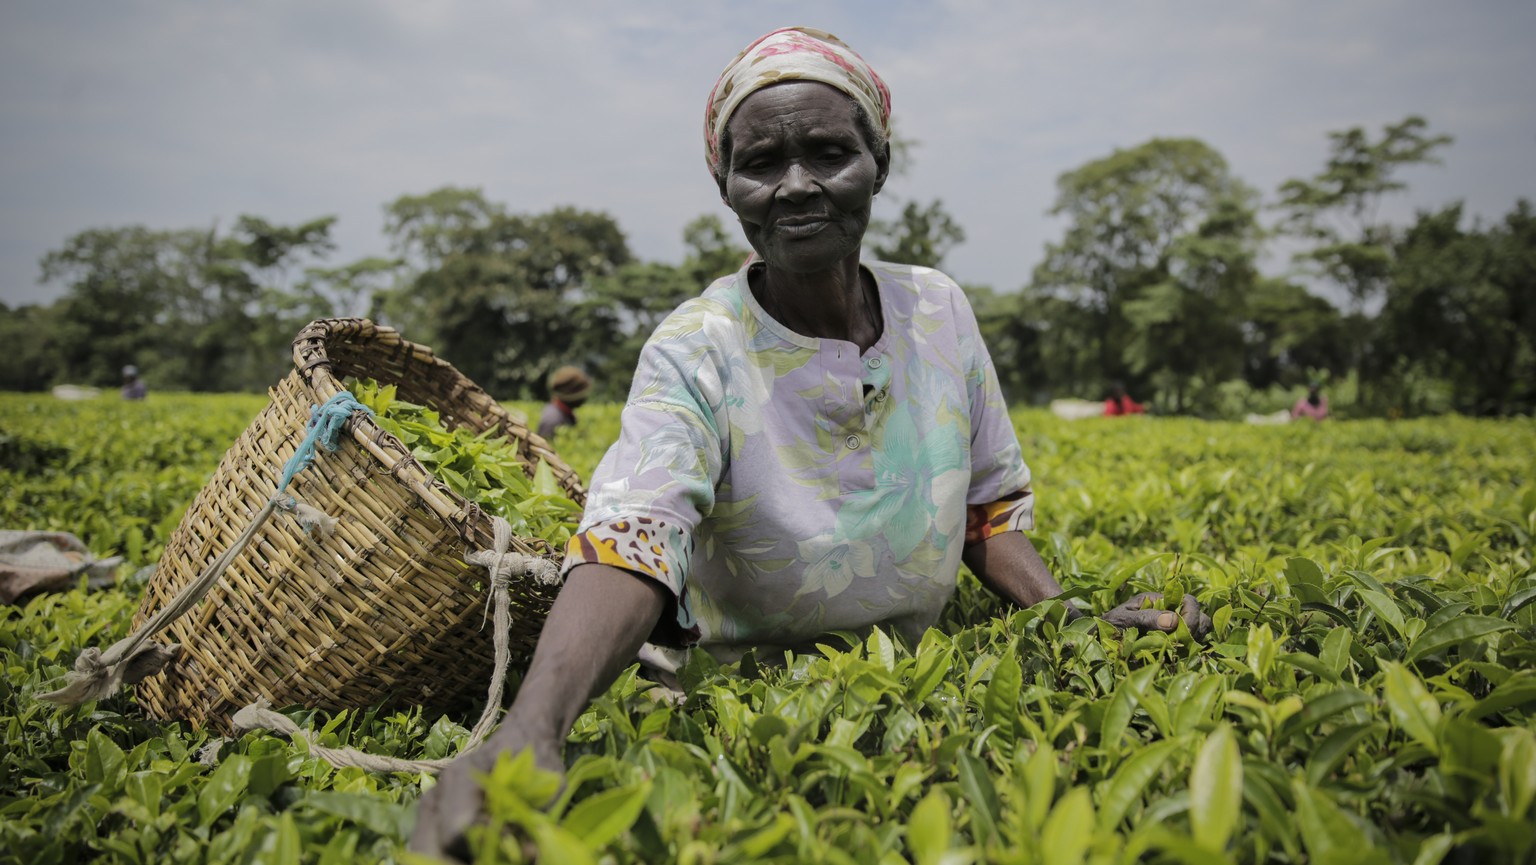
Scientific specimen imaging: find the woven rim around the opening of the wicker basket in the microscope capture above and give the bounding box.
[293,318,587,555]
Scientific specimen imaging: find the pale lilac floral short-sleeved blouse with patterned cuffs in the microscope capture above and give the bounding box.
[565,261,1034,659]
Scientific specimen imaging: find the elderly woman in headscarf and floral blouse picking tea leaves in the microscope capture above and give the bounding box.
[413,28,1200,851]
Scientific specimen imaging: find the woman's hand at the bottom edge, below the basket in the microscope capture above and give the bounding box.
[410,727,565,862]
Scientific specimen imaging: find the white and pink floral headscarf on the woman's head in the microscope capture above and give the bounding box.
[703,28,891,177]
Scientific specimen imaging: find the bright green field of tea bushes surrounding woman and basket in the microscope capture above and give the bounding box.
[0,393,1536,865]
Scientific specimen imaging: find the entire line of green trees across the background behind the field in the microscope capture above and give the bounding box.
[0,117,1536,416]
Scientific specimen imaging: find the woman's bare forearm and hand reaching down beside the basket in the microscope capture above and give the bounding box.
[410,564,671,859]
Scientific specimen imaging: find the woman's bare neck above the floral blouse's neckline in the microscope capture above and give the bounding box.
[746,254,883,352]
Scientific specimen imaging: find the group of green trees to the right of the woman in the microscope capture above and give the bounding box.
[995,117,1536,419]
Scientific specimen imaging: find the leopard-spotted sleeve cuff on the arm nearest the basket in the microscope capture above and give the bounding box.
[561,516,699,645]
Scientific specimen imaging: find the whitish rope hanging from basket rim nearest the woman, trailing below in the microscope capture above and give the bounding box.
[232,516,559,773]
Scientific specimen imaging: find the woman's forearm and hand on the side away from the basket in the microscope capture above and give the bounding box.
[962,532,1210,636]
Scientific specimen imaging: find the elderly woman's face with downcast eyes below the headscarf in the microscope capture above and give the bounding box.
[720,81,889,273]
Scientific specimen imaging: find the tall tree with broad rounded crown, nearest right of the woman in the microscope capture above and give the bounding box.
[1026,138,1260,410]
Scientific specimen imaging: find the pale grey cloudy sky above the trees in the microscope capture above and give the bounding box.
[0,0,1536,306]
